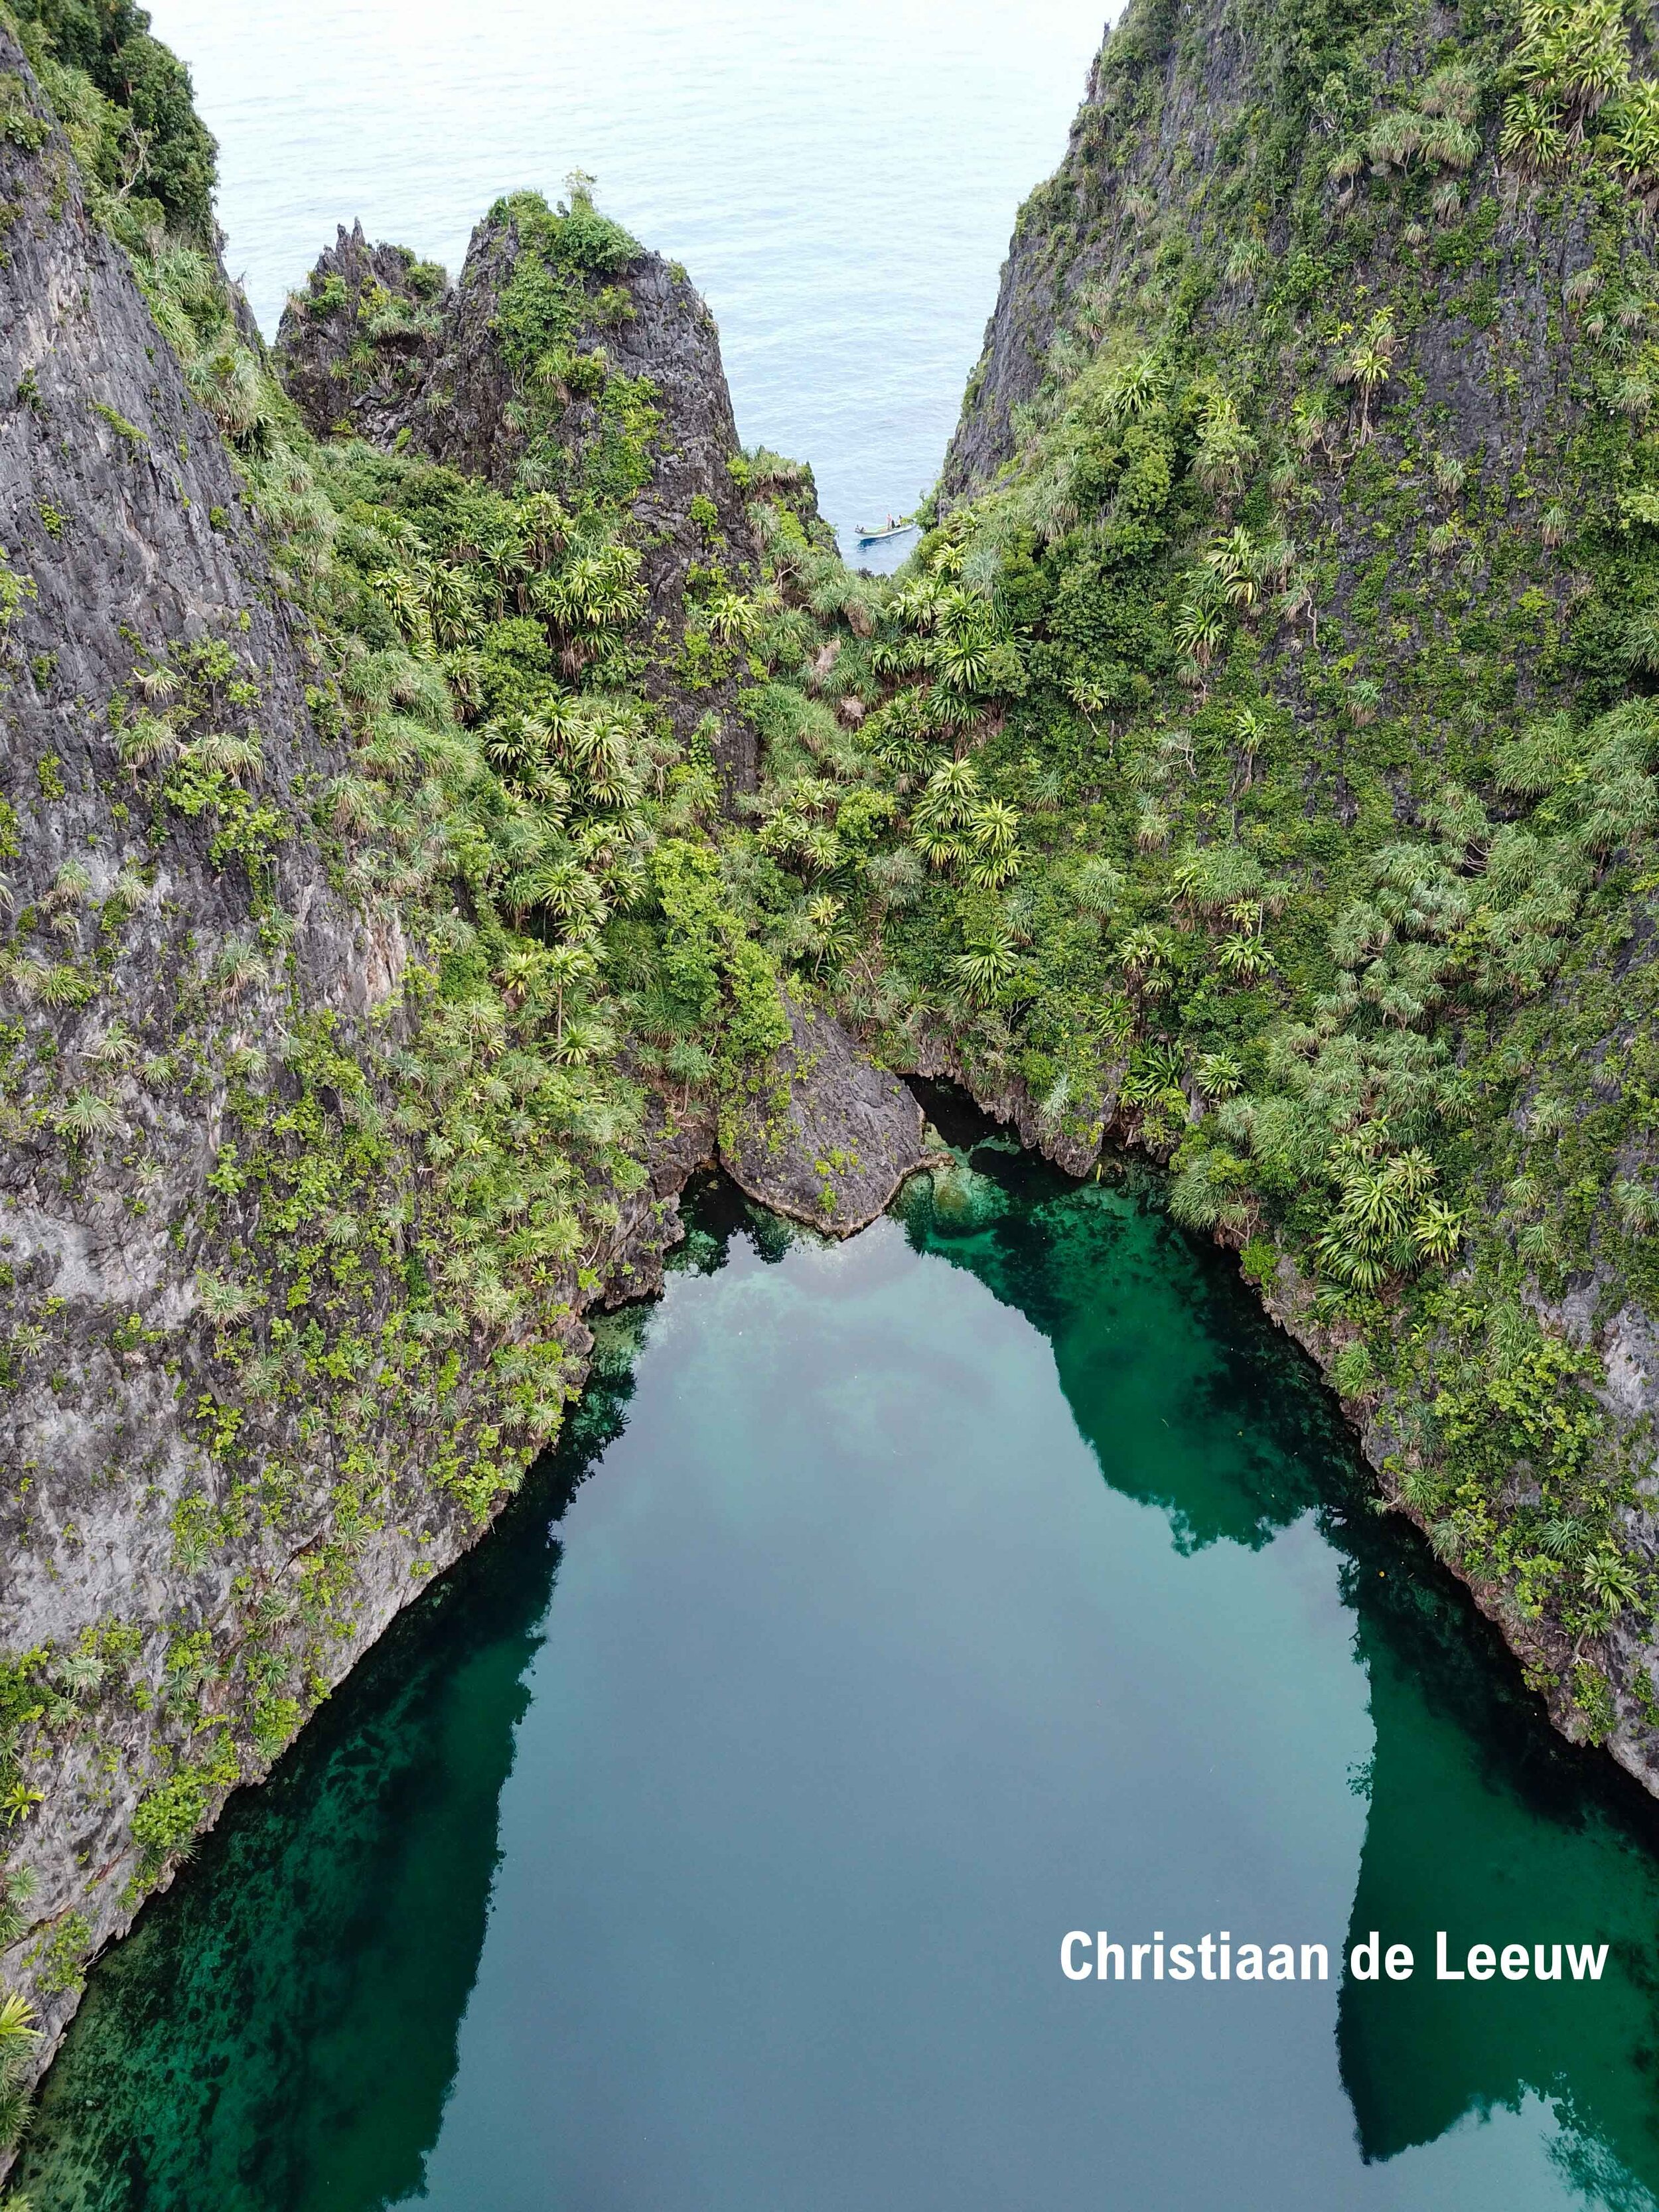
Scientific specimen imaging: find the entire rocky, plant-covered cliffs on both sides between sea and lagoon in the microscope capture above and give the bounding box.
[0,0,1659,2159]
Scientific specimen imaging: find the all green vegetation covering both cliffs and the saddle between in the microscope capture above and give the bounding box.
[0,0,1659,2123]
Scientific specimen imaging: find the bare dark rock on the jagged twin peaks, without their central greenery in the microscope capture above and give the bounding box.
[277,206,757,792]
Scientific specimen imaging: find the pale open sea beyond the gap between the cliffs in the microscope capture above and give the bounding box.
[148,0,1108,566]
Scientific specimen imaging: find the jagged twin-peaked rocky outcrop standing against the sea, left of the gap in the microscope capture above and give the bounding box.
[277,201,757,792]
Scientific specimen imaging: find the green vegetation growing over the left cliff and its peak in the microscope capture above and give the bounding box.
[0,18,788,1964]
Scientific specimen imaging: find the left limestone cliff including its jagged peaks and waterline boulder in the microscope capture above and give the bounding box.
[0,13,920,2123]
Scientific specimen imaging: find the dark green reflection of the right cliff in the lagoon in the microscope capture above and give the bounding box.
[924,1088,1659,2205]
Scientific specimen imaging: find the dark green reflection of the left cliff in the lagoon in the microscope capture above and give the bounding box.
[20,1367,630,2212]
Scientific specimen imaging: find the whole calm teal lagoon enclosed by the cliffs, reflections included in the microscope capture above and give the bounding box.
[25,1124,1659,2212]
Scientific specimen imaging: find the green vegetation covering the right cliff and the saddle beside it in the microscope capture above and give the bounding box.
[677,7,1659,1736]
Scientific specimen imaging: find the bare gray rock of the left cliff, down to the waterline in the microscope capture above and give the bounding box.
[0,29,694,2106]
